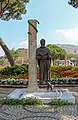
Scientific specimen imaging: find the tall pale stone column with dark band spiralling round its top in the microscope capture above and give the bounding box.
[28,19,38,91]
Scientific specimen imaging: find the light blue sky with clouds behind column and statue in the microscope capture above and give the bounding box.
[0,0,78,56]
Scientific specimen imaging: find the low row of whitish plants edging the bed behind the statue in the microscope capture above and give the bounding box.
[0,78,78,86]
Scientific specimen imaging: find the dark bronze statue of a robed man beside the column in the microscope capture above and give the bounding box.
[36,39,51,84]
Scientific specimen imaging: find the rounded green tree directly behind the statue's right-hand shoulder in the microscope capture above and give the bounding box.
[47,44,67,64]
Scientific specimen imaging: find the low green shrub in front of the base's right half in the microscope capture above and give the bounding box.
[49,98,73,106]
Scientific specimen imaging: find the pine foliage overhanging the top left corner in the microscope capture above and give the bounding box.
[0,0,29,21]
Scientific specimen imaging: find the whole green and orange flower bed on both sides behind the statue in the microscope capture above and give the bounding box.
[0,65,78,79]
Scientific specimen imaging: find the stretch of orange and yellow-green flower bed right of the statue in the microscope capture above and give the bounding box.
[51,66,78,78]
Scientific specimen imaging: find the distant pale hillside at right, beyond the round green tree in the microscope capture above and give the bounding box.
[56,44,78,55]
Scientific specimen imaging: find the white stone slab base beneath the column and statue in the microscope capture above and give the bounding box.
[8,89,75,103]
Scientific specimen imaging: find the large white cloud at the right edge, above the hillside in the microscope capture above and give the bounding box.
[56,27,78,40]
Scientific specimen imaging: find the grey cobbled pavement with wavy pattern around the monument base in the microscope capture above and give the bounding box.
[0,88,78,120]
